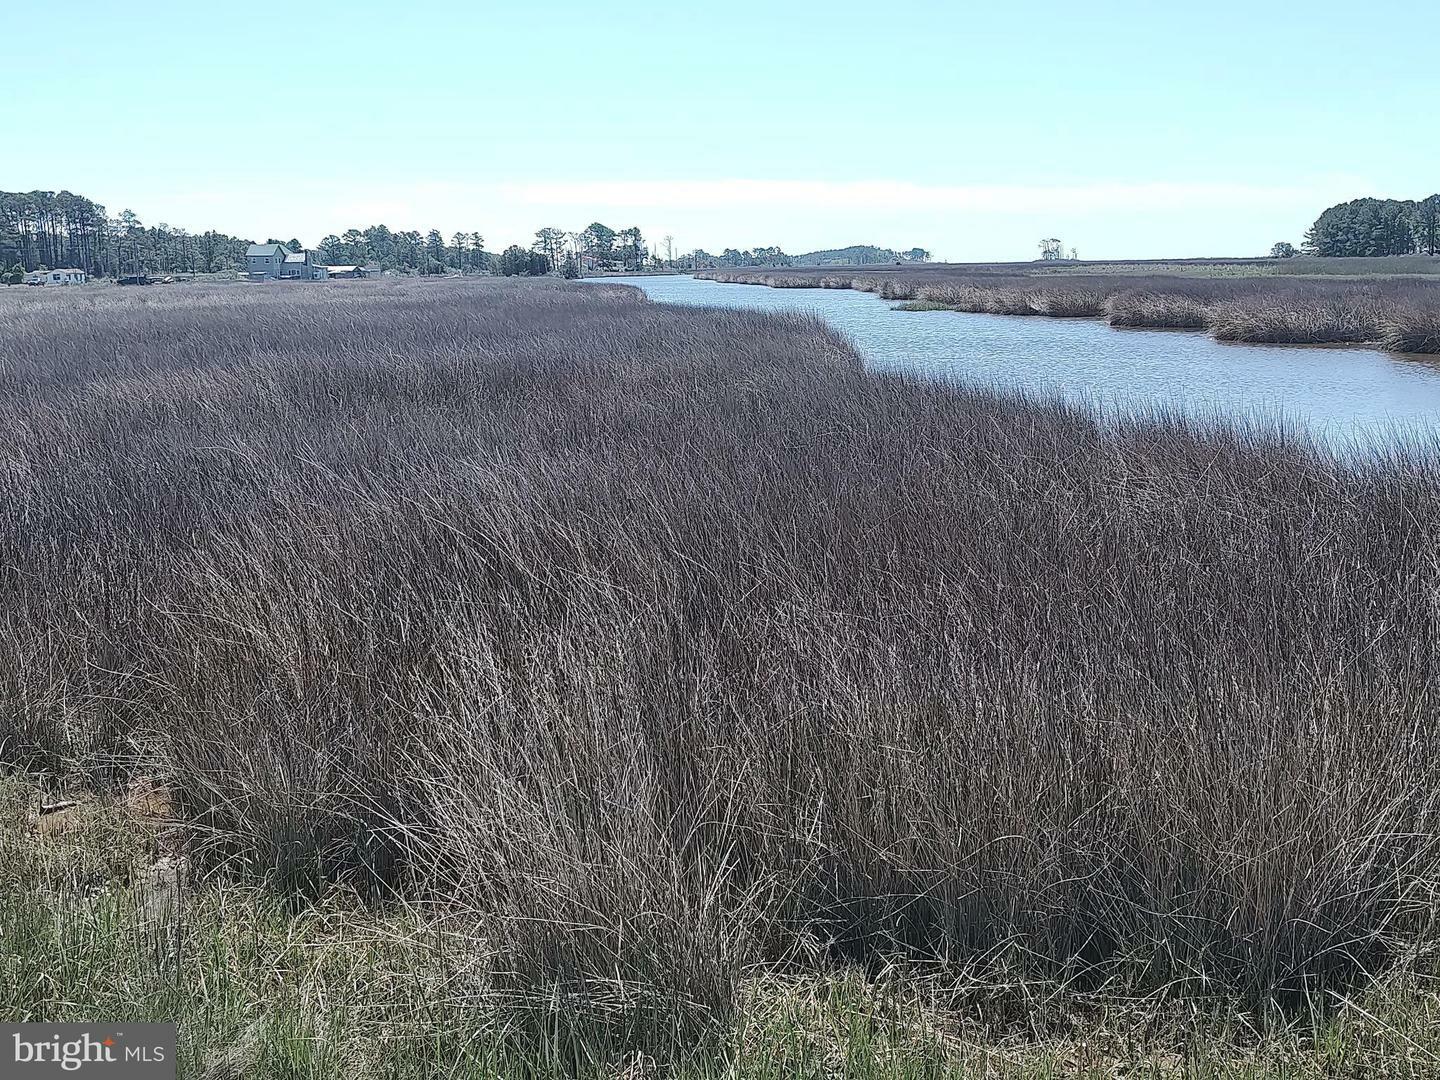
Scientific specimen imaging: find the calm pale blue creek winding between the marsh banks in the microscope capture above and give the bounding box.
[590,276,1440,446]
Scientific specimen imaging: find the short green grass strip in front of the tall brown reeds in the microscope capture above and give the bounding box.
[11,775,1440,1080]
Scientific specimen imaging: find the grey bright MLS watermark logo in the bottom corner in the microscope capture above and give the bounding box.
[0,1024,176,1080]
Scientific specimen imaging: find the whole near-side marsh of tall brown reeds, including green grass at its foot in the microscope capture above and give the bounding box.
[8,281,1440,1076]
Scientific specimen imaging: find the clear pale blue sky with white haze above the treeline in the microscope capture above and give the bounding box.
[0,0,1440,259]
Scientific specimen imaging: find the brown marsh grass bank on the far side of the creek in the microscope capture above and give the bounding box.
[697,264,1440,353]
